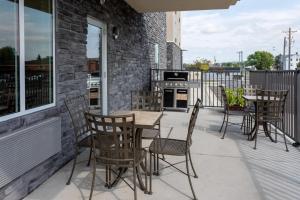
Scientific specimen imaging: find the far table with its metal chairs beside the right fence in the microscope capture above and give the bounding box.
[219,86,288,151]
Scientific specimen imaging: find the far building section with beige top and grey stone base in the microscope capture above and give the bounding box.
[167,11,182,69]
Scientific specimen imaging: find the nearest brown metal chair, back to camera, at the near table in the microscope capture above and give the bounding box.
[85,113,147,200]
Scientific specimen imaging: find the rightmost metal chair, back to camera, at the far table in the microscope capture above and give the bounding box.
[253,90,289,151]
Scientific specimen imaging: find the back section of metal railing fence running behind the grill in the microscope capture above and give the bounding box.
[151,69,248,107]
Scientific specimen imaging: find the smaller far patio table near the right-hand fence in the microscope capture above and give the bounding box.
[243,95,279,142]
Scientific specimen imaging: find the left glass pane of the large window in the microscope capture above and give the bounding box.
[0,0,19,116]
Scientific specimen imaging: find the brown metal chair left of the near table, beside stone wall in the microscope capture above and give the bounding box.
[65,95,92,185]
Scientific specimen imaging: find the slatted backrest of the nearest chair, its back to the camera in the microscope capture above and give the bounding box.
[85,113,136,161]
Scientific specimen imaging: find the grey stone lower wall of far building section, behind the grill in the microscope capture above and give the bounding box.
[167,42,182,70]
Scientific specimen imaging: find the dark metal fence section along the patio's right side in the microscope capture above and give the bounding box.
[249,70,300,143]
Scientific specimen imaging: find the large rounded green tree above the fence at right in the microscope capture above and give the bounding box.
[246,51,275,70]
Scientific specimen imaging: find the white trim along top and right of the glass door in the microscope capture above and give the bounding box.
[87,16,108,115]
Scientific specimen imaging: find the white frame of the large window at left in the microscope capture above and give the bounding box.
[0,0,56,122]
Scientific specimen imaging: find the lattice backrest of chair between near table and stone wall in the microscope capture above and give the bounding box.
[65,95,90,142]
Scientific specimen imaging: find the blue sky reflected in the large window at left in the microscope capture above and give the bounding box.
[0,0,53,61]
